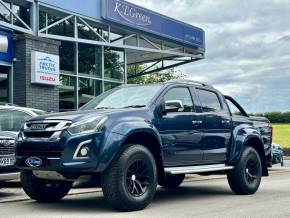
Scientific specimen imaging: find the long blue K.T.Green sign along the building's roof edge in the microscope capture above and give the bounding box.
[102,0,205,50]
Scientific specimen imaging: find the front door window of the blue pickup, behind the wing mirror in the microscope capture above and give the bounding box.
[164,88,195,112]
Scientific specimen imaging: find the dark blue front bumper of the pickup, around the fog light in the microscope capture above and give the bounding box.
[15,131,103,173]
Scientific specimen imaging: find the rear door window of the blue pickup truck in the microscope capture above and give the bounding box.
[197,89,222,112]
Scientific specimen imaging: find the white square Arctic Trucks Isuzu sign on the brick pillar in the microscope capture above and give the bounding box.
[31,51,60,85]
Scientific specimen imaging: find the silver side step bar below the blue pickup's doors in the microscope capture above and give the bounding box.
[165,164,234,175]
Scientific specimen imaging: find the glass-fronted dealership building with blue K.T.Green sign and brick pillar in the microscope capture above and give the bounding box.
[0,0,205,111]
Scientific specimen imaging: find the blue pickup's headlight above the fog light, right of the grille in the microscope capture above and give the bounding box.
[68,116,108,135]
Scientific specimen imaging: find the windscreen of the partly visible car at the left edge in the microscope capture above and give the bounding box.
[0,110,31,132]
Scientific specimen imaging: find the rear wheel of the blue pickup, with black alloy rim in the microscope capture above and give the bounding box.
[227,147,262,195]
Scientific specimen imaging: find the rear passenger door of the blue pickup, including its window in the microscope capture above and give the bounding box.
[196,88,232,163]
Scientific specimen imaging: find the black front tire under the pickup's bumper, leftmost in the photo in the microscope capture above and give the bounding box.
[20,171,72,202]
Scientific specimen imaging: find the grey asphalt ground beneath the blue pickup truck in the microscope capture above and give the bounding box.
[0,161,290,218]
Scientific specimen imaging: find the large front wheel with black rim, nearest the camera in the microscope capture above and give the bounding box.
[102,145,157,211]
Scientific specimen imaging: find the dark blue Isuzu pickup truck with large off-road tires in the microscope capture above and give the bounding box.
[16,80,272,211]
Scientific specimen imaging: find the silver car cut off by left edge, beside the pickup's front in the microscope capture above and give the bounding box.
[0,104,44,182]
